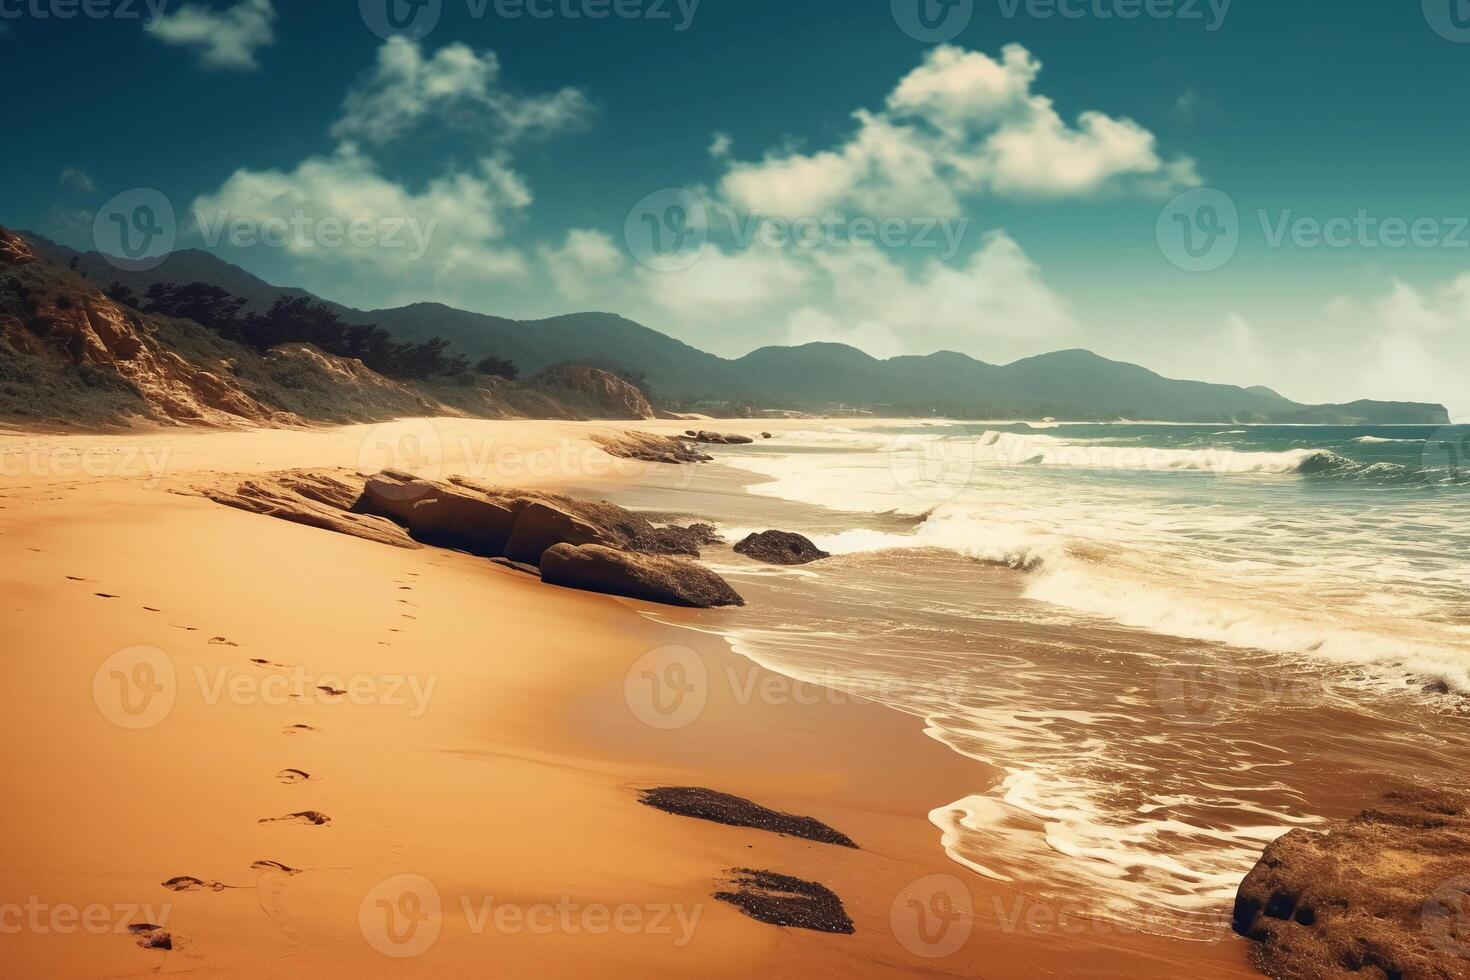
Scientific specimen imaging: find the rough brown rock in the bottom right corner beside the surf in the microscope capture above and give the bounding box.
[1235,788,1470,980]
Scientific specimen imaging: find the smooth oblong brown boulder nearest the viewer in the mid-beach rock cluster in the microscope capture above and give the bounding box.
[541,544,745,608]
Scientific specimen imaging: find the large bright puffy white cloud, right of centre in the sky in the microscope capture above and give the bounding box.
[720,44,1198,216]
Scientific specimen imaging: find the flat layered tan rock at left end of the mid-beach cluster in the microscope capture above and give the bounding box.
[200,470,419,548]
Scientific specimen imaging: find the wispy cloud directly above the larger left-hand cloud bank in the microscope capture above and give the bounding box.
[332,38,591,143]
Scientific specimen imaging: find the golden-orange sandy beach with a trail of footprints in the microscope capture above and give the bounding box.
[0,419,1255,977]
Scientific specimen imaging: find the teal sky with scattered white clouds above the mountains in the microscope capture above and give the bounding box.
[0,0,1470,417]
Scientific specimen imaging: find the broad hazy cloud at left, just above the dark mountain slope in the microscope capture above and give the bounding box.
[194,144,531,284]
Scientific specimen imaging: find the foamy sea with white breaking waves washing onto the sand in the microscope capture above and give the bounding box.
[593,422,1470,939]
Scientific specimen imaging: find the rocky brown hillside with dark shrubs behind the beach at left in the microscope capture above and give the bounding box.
[0,228,653,429]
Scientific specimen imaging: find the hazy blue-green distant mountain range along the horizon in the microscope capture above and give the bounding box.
[28,234,1449,425]
